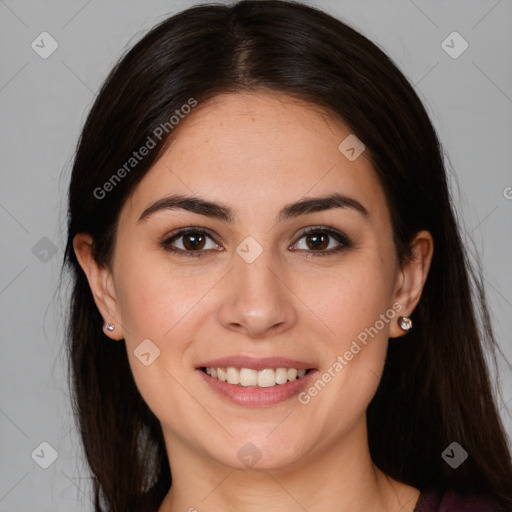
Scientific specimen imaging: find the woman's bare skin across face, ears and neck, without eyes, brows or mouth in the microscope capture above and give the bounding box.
[74,92,433,512]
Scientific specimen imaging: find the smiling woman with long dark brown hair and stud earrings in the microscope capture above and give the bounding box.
[65,0,512,512]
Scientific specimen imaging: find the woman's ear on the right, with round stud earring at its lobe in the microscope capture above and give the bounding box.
[389,231,434,338]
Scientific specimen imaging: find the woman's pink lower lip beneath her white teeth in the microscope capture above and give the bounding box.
[197,370,316,407]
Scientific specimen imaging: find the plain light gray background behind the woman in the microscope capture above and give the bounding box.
[0,0,512,512]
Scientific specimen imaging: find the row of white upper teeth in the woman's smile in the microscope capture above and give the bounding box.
[205,366,307,388]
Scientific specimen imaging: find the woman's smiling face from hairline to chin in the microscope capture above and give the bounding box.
[76,93,428,468]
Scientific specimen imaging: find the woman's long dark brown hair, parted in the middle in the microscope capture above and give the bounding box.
[64,0,512,512]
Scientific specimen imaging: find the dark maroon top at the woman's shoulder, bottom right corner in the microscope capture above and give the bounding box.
[414,490,503,512]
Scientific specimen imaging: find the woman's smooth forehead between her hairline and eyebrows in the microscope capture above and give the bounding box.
[118,92,385,226]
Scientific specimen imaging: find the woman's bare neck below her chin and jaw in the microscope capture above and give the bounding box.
[159,421,419,512]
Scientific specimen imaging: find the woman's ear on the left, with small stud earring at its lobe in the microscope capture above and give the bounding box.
[73,233,124,340]
